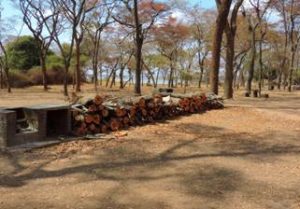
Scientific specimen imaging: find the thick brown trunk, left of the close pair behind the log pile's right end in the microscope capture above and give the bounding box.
[210,0,232,94]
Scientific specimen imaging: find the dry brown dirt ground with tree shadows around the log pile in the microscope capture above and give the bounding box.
[0,85,300,209]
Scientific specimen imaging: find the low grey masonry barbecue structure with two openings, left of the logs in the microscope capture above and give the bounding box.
[0,105,71,147]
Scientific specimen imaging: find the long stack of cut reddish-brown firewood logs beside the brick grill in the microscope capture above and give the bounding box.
[72,94,223,136]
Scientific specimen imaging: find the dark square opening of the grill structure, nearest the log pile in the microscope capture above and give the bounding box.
[46,110,68,137]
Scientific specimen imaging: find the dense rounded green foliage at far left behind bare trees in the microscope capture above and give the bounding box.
[7,36,40,70]
